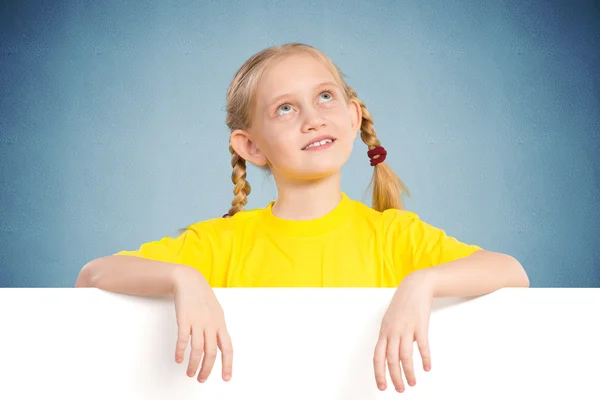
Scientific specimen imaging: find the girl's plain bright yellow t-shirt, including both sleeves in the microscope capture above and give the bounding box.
[116,194,481,288]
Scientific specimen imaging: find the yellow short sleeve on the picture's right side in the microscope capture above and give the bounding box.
[387,210,483,276]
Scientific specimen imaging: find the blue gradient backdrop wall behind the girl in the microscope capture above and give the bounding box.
[0,0,600,287]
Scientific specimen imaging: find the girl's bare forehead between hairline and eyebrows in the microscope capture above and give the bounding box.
[257,53,337,101]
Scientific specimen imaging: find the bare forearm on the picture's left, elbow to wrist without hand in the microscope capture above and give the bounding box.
[75,255,208,296]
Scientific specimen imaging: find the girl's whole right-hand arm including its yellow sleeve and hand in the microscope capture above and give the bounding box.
[373,212,529,392]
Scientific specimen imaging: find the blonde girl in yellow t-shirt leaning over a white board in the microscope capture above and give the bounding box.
[76,44,529,392]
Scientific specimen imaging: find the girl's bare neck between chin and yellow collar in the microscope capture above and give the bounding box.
[272,173,342,220]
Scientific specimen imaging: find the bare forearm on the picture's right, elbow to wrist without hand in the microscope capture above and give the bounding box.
[421,251,529,297]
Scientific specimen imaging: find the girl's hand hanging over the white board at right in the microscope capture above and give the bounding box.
[373,270,433,393]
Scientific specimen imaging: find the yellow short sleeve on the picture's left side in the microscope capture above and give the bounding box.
[114,226,219,280]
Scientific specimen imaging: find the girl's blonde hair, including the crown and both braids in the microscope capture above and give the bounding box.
[225,43,410,216]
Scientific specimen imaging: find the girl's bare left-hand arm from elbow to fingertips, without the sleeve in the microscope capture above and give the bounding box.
[75,255,233,382]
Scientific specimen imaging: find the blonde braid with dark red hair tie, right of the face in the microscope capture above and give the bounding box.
[348,87,410,211]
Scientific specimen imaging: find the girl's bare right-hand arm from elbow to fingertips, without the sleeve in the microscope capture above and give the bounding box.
[373,250,529,392]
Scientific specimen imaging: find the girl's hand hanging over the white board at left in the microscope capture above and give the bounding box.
[174,267,233,382]
